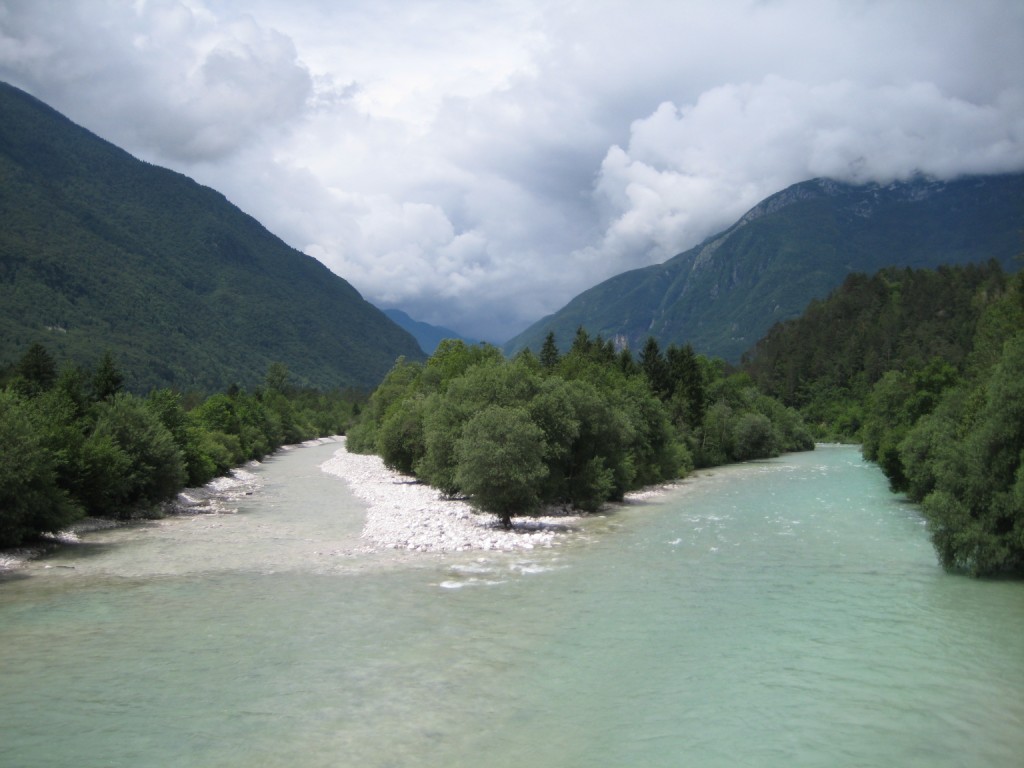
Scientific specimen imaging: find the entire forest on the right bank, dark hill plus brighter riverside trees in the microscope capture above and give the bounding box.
[745,262,1024,575]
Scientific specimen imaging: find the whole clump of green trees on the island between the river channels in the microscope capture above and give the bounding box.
[348,329,813,526]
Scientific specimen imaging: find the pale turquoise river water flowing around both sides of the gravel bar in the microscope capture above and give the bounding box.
[0,444,1024,768]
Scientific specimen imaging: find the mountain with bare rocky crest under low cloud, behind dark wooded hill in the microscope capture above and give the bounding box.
[505,174,1024,361]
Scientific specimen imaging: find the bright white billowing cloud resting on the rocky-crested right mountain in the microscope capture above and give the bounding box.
[596,76,1024,270]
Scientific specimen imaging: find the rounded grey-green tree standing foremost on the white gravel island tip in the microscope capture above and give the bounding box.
[456,406,548,528]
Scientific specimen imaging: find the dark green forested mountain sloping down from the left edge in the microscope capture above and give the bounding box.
[0,83,424,391]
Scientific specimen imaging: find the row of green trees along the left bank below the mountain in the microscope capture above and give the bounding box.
[0,344,360,547]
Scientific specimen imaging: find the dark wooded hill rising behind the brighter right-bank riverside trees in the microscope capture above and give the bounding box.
[742,261,1008,439]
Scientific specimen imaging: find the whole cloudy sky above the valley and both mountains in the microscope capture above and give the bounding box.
[0,0,1024,343]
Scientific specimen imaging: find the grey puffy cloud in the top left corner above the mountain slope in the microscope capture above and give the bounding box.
[0,0,311,163]
